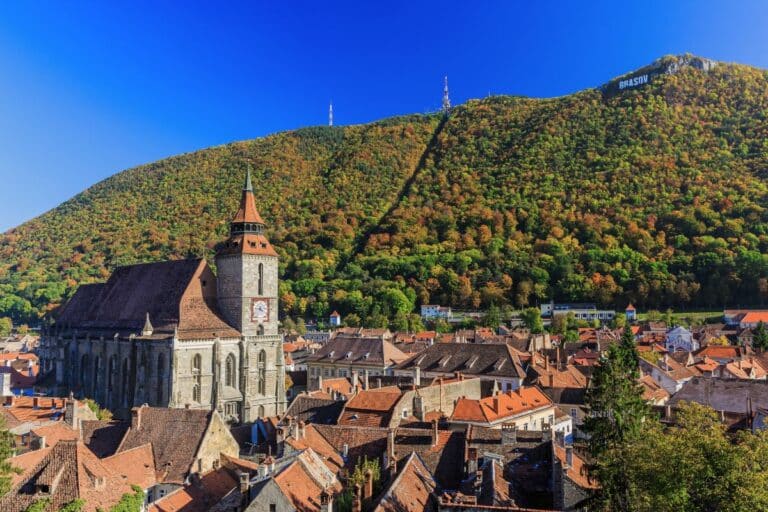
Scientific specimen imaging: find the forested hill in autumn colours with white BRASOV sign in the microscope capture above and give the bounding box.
[0,54,768,326]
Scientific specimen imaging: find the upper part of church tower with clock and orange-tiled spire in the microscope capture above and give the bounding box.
[216,170,278,336]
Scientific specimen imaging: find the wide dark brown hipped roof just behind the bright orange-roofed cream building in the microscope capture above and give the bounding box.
[397,343,525,378]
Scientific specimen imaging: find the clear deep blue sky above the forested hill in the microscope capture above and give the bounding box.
[0,0,768,231]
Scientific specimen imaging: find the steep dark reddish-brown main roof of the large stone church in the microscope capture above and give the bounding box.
[57,259,238,336]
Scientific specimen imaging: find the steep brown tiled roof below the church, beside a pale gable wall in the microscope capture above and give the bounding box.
[118,407,213,483]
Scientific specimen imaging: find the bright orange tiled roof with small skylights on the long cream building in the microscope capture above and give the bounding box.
[451,386,552,423]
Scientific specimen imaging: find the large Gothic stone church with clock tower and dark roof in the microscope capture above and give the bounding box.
[39,172,286,422]
